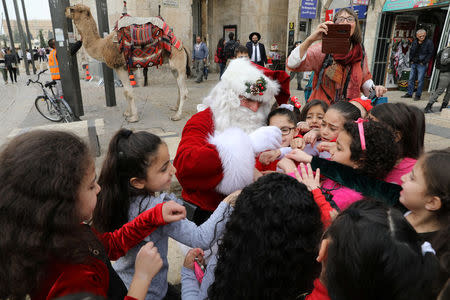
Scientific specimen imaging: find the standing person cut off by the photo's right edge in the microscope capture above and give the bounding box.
[425,41,450,113]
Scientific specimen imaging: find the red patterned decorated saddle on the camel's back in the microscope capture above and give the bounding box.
[114,14,183,70]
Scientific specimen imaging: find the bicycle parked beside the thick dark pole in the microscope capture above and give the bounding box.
[27,70,75,123]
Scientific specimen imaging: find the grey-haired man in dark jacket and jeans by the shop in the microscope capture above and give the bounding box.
[402,29,434,101]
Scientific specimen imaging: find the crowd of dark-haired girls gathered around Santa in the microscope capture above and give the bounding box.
[0,95,450,300]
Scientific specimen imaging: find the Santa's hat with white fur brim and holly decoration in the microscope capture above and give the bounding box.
[220,58,289,103]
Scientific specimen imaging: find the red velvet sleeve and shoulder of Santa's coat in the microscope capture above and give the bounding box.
[173,108,225,211]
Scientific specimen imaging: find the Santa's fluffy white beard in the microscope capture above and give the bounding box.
[203,82,272,134]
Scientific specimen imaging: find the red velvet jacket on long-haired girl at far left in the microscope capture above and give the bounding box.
[31,204,166,300]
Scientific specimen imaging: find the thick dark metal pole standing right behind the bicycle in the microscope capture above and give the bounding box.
[48,0,84,117]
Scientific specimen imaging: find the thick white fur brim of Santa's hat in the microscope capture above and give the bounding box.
[220,58,280,103]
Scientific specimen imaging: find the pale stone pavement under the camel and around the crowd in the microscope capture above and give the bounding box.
[0,66,450,282]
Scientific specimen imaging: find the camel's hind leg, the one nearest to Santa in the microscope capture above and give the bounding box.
[169,48,188,121]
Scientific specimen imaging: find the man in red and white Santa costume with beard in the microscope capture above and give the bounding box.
[173,58,289,224]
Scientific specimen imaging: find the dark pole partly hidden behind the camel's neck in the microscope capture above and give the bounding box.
[95,0,116,106]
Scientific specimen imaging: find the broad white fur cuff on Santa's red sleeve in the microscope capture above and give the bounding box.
[209,128,255,195]
